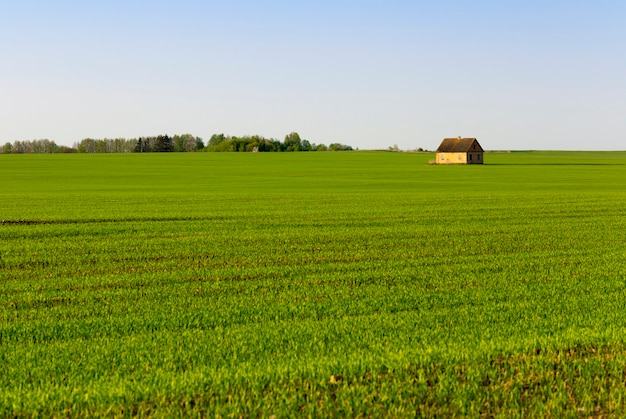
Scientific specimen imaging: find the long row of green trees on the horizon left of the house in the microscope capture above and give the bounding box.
[0,132,352,154]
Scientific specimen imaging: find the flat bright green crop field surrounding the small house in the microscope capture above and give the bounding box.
[0,152,626,417]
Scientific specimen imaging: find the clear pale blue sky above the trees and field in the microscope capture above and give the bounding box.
[0,0,626,150]
